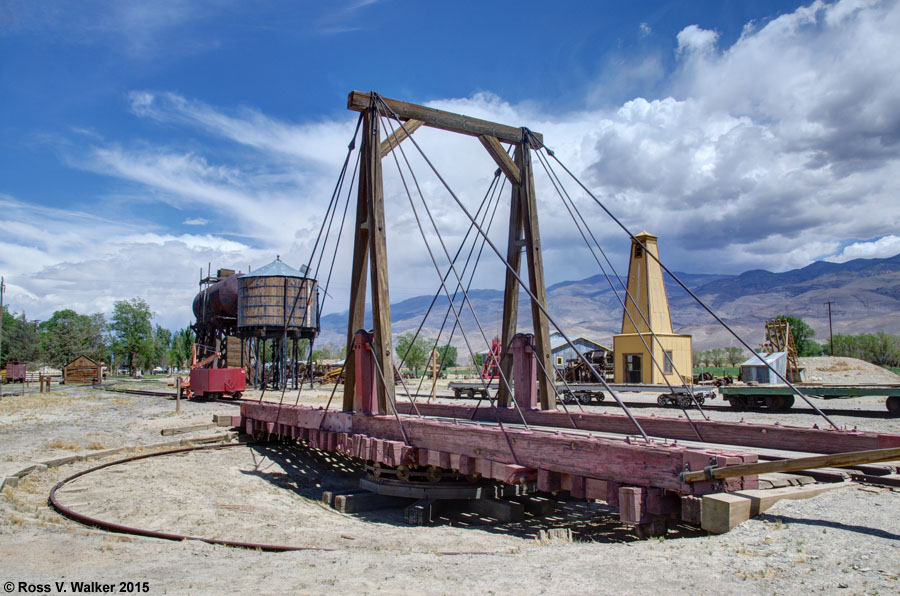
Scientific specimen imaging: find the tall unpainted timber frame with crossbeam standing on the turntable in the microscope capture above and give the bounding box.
[344,91,555,414]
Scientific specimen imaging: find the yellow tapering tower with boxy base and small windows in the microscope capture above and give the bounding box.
[613,232,692,385]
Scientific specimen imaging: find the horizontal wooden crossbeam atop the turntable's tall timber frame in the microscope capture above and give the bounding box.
[347,91,544,143]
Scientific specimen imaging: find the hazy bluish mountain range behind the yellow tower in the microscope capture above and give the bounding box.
[320,255,900,349]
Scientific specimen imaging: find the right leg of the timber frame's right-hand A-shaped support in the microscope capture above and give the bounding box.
[516,143,556,410]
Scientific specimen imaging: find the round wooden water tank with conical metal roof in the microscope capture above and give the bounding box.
[237,259,318,337]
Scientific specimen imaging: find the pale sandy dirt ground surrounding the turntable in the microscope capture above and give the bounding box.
[0,381,900,594]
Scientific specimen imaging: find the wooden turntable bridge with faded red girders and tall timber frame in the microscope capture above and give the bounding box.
[235,91,900,529]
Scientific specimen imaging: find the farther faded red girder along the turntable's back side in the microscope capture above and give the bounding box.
[397,401,900,453]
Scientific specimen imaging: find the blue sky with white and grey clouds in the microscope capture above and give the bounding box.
[0,0,900,328]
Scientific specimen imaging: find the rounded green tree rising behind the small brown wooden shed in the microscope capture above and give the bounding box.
[38,309,106,367]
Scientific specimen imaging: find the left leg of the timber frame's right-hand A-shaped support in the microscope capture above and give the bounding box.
[496,143,524,408]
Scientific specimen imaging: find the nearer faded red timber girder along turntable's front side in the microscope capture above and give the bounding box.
[241,403,756,494]
